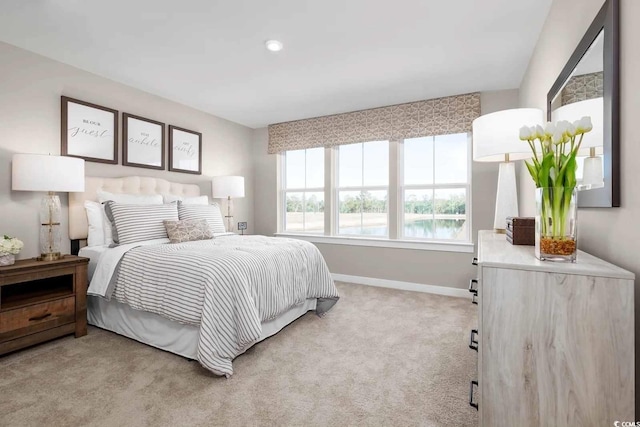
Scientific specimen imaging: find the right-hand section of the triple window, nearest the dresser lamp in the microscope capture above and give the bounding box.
[399,133,470,241]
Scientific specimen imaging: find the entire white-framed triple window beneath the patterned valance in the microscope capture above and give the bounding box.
[280,133,471,250]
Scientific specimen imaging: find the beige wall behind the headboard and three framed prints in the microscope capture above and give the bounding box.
[0,42,254,258]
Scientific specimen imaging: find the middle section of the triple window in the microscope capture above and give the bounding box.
[337,141,389,236]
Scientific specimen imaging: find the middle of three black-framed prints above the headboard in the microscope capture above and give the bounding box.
[122,113,165,170]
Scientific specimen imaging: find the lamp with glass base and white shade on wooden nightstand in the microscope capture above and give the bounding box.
[11,154,84,261]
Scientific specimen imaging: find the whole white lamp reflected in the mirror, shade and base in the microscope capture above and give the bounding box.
[551,97,604,190]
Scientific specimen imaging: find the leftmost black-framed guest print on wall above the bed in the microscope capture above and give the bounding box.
[60,96,118,164]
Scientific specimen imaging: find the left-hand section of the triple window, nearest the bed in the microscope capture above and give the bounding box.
[282,147,324,234]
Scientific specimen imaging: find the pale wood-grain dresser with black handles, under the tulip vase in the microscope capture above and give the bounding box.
[472,231,635,427]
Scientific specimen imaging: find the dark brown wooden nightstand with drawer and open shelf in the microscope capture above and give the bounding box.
[0,255,89,354]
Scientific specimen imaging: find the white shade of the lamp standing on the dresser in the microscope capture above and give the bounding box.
[473,108,544,162]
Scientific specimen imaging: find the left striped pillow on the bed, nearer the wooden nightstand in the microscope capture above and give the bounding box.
[105,201,178,246]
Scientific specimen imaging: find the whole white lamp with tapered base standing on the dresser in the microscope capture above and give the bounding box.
[473,108,543,232]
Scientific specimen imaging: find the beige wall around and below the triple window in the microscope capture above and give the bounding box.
[253,90,518,288]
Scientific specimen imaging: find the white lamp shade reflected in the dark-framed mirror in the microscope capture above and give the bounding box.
[551,97,604,156]
